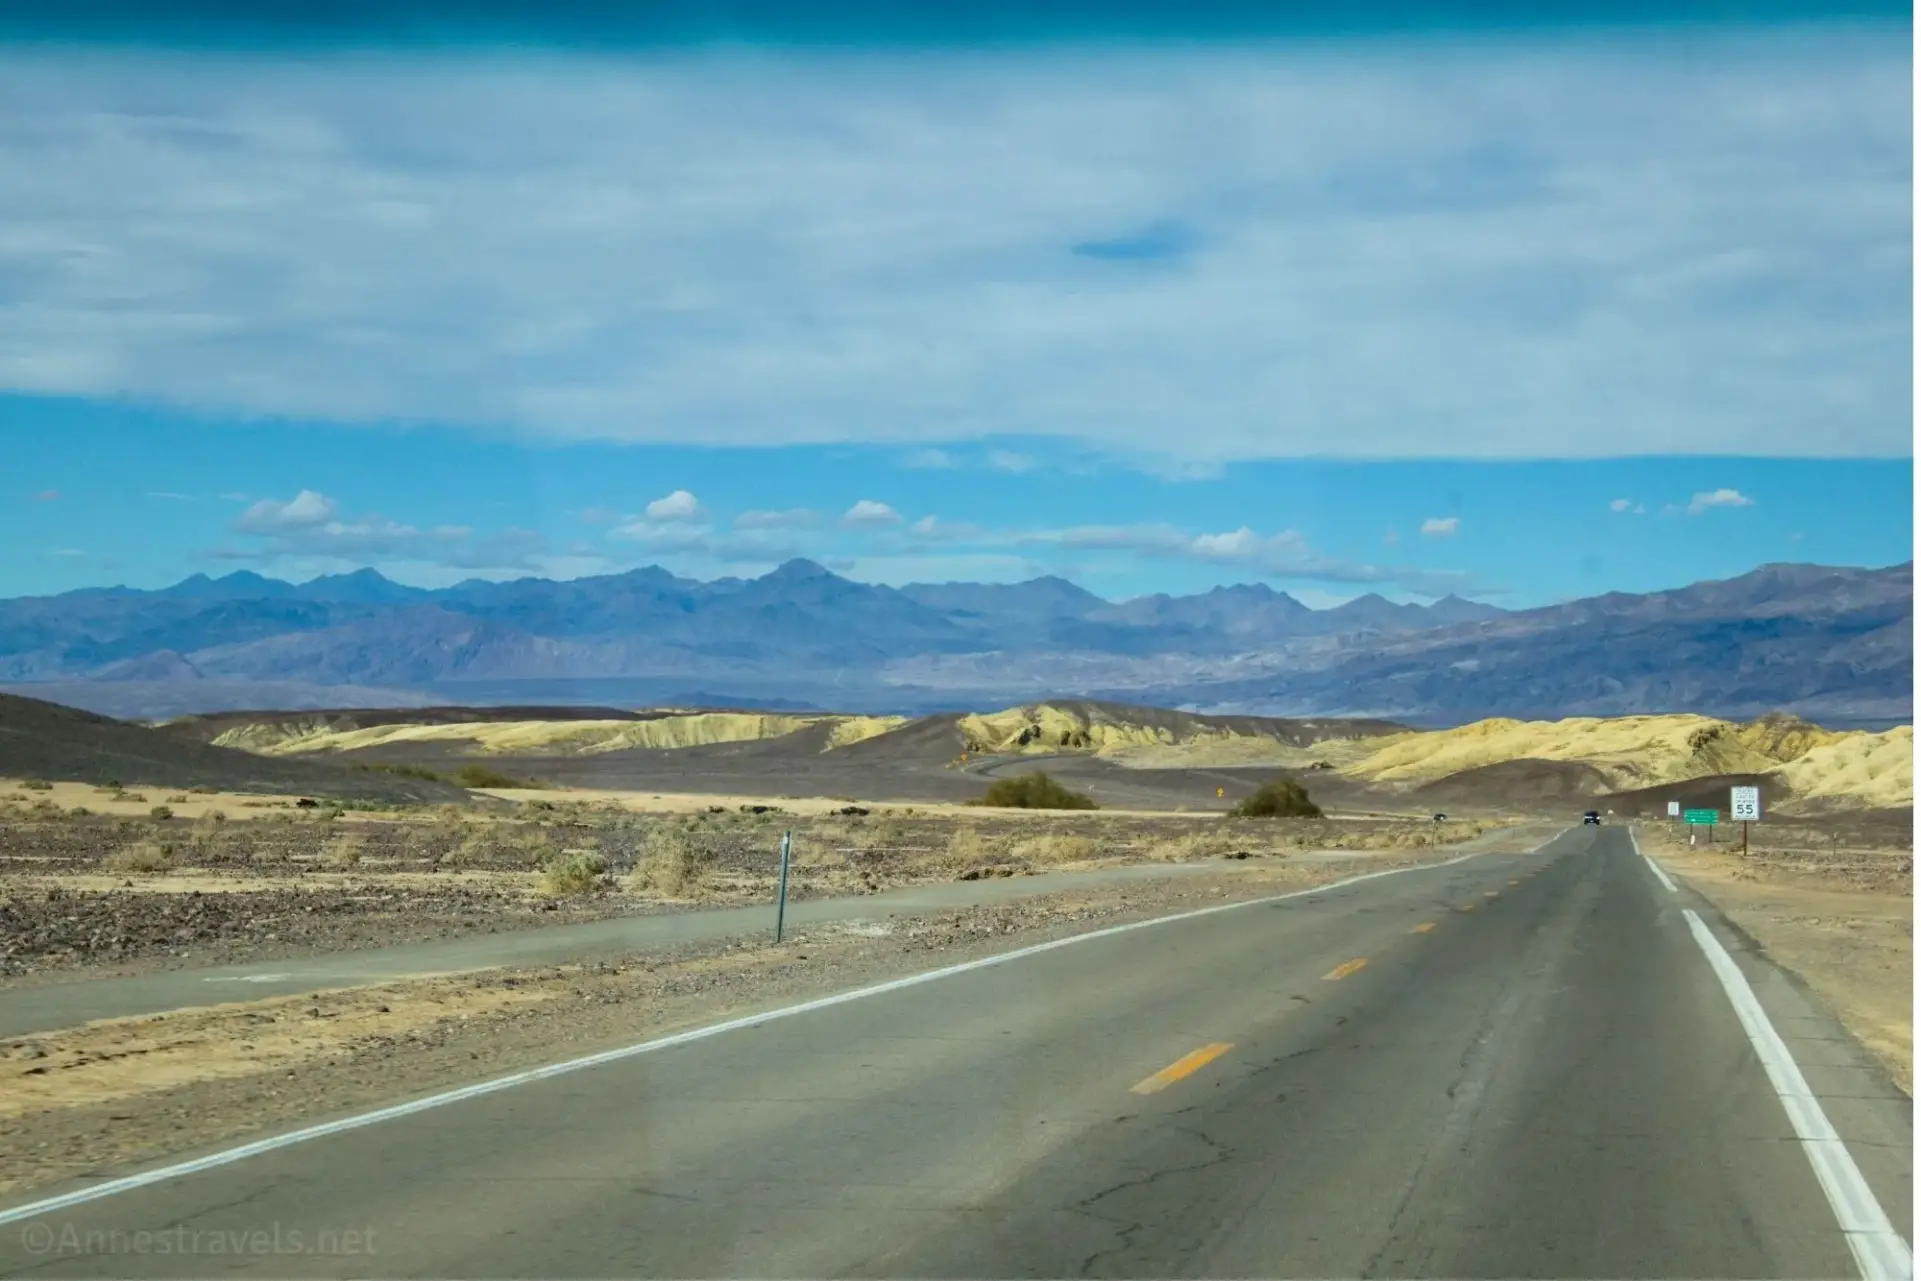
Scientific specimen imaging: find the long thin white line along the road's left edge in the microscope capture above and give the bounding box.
[0,834,1560,1225]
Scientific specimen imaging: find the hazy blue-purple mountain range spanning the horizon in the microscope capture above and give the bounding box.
[0,561,1913,722]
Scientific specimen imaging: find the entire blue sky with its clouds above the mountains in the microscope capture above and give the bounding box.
[0,2,1913,605]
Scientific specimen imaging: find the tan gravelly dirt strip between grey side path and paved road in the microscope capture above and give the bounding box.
[0,847,1483,1191]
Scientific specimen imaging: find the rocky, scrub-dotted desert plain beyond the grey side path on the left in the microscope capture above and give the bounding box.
[0,805,1496,983]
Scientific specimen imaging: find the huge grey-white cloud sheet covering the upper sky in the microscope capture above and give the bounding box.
[0,33,1913,465]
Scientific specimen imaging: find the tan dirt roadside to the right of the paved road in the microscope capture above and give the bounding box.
[1639,814,1915,1095]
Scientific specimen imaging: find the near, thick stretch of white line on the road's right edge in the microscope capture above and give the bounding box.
[1683,908,1915,1281]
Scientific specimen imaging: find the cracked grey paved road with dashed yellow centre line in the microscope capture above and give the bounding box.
[0,828,1911,1277]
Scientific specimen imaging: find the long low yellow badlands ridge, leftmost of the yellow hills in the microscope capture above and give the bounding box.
[213,713,907,757]
